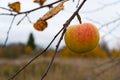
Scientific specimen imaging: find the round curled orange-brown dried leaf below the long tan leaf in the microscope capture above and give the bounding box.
[34,18,47,31]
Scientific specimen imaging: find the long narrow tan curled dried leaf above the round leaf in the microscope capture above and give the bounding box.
[42,0,67,20]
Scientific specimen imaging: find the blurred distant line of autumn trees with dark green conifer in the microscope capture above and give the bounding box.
[0,33,120,58]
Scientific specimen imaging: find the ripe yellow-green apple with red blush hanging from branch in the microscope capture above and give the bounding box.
[64,23,99,53]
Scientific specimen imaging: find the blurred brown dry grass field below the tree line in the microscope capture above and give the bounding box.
[0,57,120,80]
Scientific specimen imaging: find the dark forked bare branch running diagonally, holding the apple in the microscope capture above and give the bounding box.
[8,0,86,80]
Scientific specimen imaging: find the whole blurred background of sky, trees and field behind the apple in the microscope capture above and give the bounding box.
[0,0,120,80]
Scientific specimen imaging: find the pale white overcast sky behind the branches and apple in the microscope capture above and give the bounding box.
[0,0,120,48]
